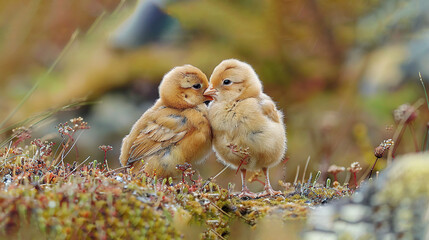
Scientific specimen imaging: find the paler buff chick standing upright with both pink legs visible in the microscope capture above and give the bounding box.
[204,59,286,198]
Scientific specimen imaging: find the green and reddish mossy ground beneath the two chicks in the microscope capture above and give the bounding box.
[0,119,352,239]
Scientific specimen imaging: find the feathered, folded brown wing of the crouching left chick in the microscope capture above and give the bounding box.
[127,114,187,165]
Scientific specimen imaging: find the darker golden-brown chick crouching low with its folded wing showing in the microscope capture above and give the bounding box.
[119,65,212,177]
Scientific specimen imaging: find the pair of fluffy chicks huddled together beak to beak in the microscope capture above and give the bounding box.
[120,59,286,198]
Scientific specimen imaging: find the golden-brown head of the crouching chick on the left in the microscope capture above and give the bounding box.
[159,65,211,109]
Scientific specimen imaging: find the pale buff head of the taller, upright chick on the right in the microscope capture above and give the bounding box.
[204,59,262,101]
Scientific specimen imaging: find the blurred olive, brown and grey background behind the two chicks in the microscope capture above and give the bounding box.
[0,0,429,190]
